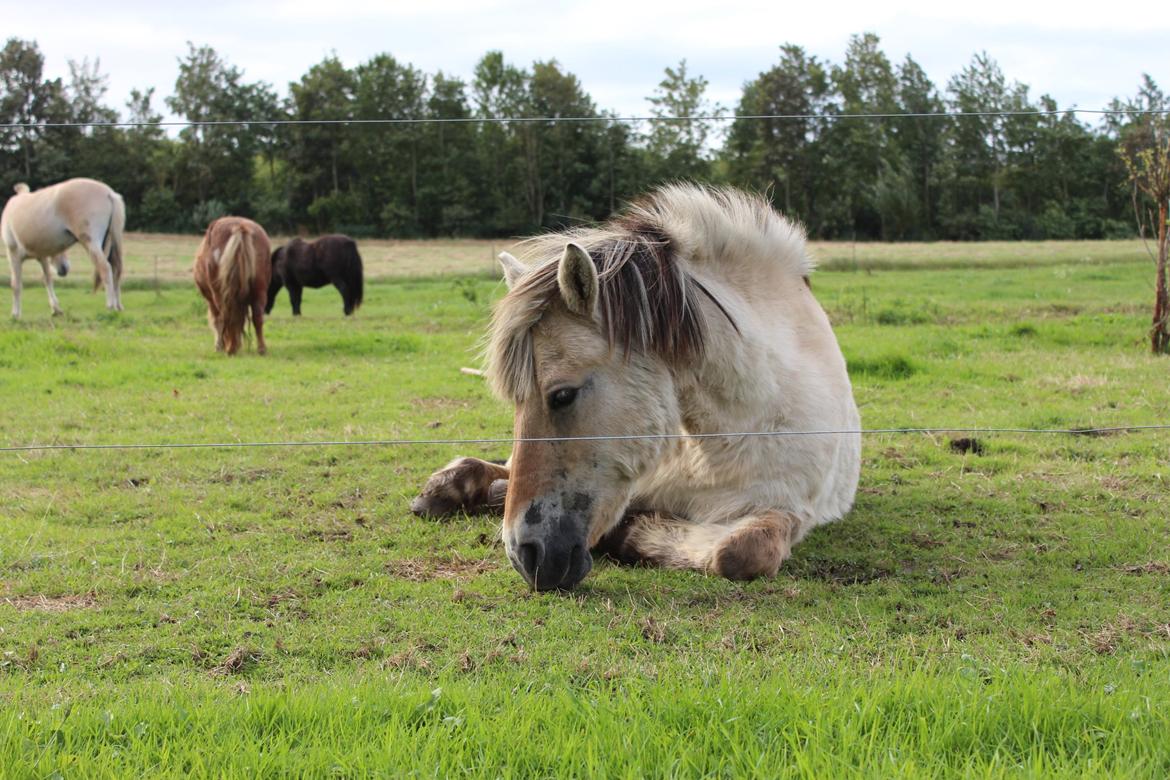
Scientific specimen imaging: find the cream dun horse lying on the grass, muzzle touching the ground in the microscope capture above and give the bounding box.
[412,185,861,591]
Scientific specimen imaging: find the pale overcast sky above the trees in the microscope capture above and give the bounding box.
[9,0,1170,124]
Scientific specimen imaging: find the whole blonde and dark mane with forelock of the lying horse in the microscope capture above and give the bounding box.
[486,185,812,403]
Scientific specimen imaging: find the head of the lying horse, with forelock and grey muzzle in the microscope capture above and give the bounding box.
[488,236,702,591]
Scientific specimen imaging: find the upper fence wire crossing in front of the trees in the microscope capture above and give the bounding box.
[0,108,1170,130]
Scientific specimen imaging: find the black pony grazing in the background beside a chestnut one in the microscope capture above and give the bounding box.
[264,235,362,317]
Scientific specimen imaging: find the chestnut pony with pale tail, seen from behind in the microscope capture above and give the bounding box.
[194,216,271,354]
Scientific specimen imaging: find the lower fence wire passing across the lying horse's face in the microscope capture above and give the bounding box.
[0,423,1170,453]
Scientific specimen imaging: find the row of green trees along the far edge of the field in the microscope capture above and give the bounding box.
[0,34,1170,240]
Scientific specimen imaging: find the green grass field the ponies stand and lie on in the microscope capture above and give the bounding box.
[0,237,1170,778]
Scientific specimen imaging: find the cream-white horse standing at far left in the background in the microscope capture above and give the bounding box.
[0,179,126,318]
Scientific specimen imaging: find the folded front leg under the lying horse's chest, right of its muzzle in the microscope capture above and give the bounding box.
[593,510,800,580]
